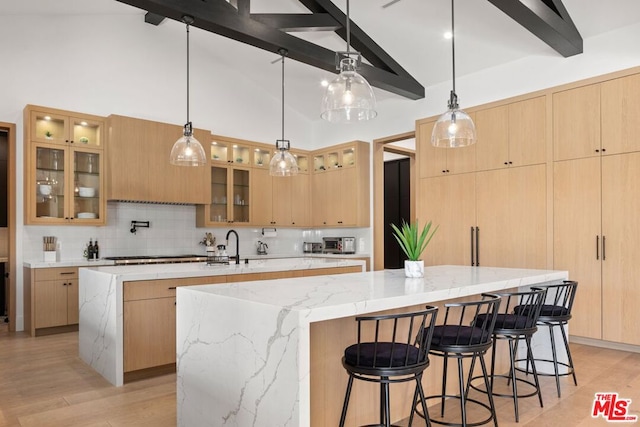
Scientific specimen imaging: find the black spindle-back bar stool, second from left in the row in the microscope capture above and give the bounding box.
[409,294,501,427]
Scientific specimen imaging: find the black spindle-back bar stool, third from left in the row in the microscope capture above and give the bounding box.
[471,288,546,422]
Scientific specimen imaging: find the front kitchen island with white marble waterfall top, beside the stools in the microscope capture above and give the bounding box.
[177,266,568,427]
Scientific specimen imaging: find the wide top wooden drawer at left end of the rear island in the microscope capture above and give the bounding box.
[123,276,227,301]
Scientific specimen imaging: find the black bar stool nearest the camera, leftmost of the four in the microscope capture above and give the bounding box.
[340,306,438,427]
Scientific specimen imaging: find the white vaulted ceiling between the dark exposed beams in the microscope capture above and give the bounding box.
[0,0,640,120]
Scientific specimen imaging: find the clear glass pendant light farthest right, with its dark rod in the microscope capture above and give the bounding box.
[431,0,476,148]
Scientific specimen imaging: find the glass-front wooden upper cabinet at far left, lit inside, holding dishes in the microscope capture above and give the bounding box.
[24,105,106,225]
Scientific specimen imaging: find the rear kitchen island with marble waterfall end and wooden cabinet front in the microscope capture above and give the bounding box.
[78,258,365,386]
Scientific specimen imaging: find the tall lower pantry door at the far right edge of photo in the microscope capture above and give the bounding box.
[604,153,640,345]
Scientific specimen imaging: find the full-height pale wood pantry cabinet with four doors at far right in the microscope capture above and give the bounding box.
[553,75,640,345]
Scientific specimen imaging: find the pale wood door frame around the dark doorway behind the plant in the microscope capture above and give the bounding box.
[373,131,417,270]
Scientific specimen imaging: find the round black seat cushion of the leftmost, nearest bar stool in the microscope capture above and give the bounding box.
[344,342,426,368]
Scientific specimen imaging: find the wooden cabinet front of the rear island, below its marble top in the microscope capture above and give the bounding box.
[123,266,362,382]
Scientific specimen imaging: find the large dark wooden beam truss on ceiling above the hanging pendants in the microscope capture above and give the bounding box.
[118,0,425,99]
